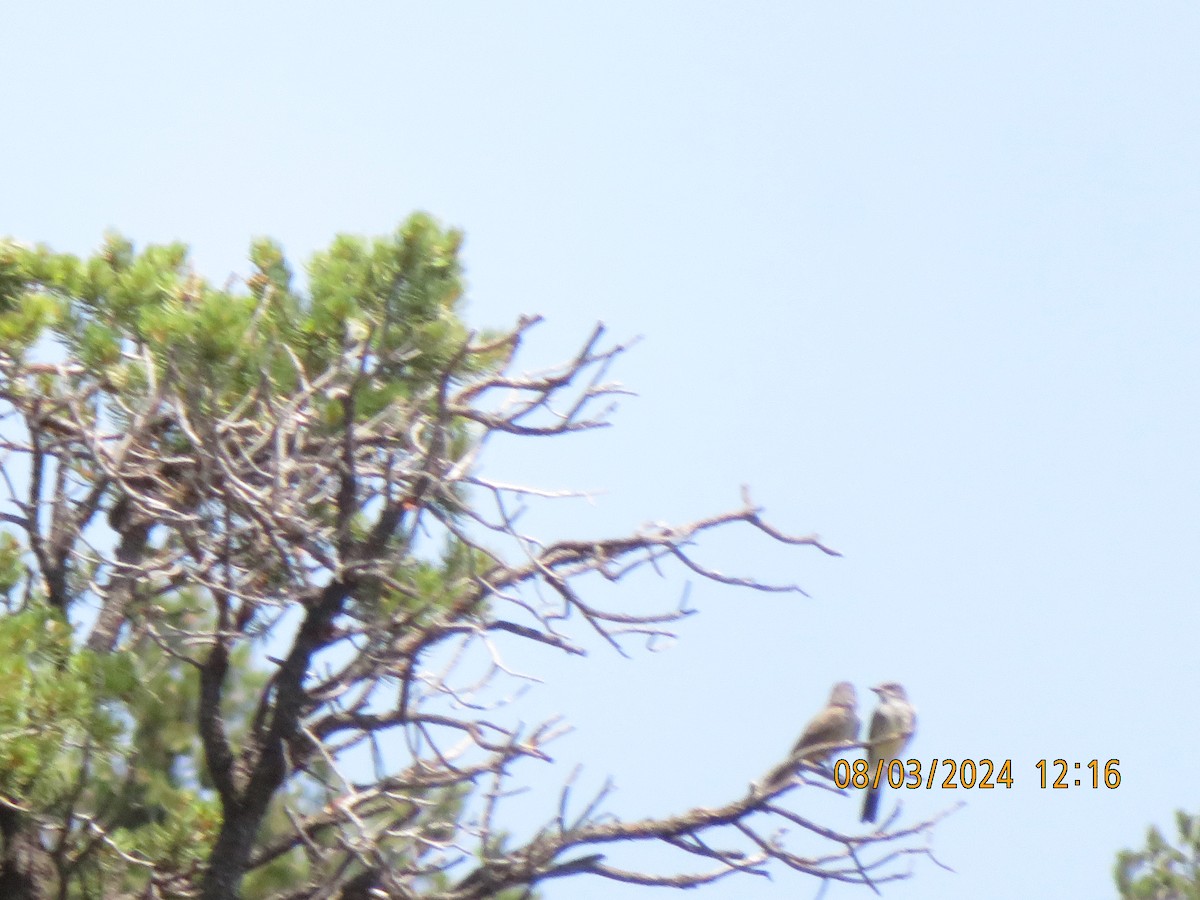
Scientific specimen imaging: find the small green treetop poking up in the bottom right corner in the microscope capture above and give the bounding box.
[1114,810,1200,900]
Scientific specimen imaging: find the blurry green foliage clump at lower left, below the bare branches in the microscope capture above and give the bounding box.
[0,606,220,881]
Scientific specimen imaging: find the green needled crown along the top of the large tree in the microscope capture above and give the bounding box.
[0,214,492,434]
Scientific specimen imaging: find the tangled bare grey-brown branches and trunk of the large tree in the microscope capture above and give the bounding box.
[0,312,944,900]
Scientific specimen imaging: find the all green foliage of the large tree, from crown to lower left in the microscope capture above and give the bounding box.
[0,215,516,896]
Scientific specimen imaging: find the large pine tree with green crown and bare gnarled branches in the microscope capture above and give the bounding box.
[0,215,950,900]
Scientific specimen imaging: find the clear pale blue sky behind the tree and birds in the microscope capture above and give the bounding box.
[0,0,1200,900]
